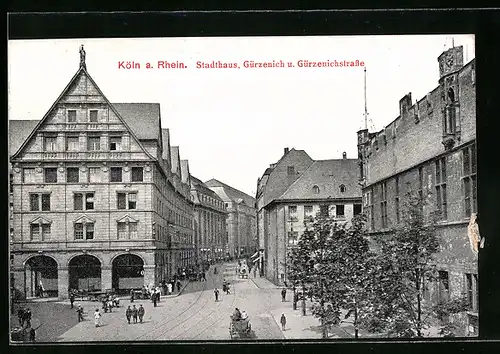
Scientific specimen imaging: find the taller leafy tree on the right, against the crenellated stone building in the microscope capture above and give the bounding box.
[367,191,463,337]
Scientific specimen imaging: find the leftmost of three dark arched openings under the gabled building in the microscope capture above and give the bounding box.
[24,255,58,297]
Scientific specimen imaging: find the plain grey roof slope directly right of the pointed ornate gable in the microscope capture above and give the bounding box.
[111,103,160,140]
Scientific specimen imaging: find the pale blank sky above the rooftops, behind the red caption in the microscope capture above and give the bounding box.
[8,35,474,197]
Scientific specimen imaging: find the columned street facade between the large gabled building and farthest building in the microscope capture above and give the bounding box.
[191,176,228,264]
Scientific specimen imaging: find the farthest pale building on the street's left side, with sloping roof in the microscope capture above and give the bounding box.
[205,179,257,257]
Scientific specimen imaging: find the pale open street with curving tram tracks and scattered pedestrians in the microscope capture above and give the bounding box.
[14,263,328,342]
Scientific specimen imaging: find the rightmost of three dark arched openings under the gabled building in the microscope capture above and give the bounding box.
[112,254,144,293]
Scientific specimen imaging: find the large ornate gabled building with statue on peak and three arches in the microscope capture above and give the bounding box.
[9,47,194,298]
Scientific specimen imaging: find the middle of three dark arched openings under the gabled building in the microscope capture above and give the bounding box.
[68,254,101,291]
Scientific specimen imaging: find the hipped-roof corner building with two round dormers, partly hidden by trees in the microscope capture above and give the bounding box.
[257,148,362,284]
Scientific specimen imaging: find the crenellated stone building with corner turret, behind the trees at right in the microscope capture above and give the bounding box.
[358,47,478,335]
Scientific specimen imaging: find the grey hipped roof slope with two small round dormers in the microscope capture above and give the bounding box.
[276,159,361,200]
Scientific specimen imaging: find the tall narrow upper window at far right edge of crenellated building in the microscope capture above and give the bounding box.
[462,144,477,217]
